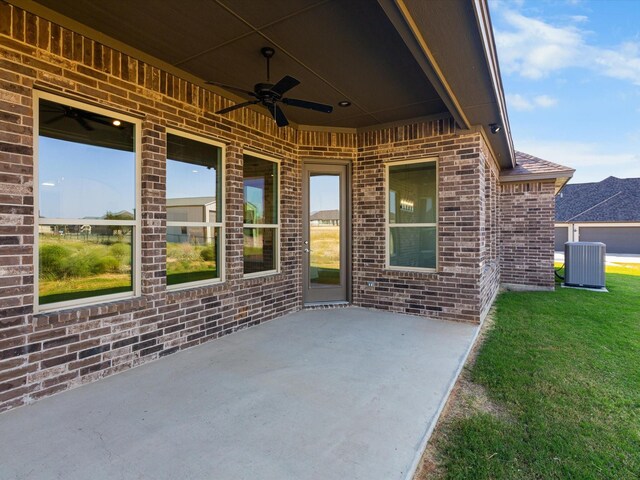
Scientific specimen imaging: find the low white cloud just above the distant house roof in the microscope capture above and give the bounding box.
[515,139,640,183]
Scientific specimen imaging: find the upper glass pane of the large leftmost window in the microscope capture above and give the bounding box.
[38,100,136,220]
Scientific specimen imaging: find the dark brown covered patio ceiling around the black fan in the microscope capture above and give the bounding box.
[21,0,513,167]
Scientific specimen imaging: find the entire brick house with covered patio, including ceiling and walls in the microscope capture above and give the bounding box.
[0,0,573,410]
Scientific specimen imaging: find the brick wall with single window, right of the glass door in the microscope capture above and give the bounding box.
[353,125,496,322]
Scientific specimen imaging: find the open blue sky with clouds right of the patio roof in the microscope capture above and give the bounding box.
[489,0,640,183]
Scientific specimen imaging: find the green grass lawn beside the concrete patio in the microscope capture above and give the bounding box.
[430,267,640,479]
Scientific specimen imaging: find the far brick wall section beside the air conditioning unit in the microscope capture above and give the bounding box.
[499,180,555,290]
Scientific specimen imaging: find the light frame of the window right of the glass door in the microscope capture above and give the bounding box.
[384,157,440,273]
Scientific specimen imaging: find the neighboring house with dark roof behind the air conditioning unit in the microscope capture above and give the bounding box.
[555,177,640,254]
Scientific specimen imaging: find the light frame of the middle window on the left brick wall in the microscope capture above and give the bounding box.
[165,128,227,291]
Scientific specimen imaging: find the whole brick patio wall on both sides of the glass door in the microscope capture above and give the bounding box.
[0,0,510,410]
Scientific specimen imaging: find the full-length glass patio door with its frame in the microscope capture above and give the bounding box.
[302,163,349,304]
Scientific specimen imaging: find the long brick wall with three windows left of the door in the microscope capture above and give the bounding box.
[0,2,308,410]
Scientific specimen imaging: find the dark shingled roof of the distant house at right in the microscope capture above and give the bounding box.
[556,177,640,222]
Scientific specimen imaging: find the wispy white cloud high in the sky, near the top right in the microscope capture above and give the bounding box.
[495,8,640,85]
